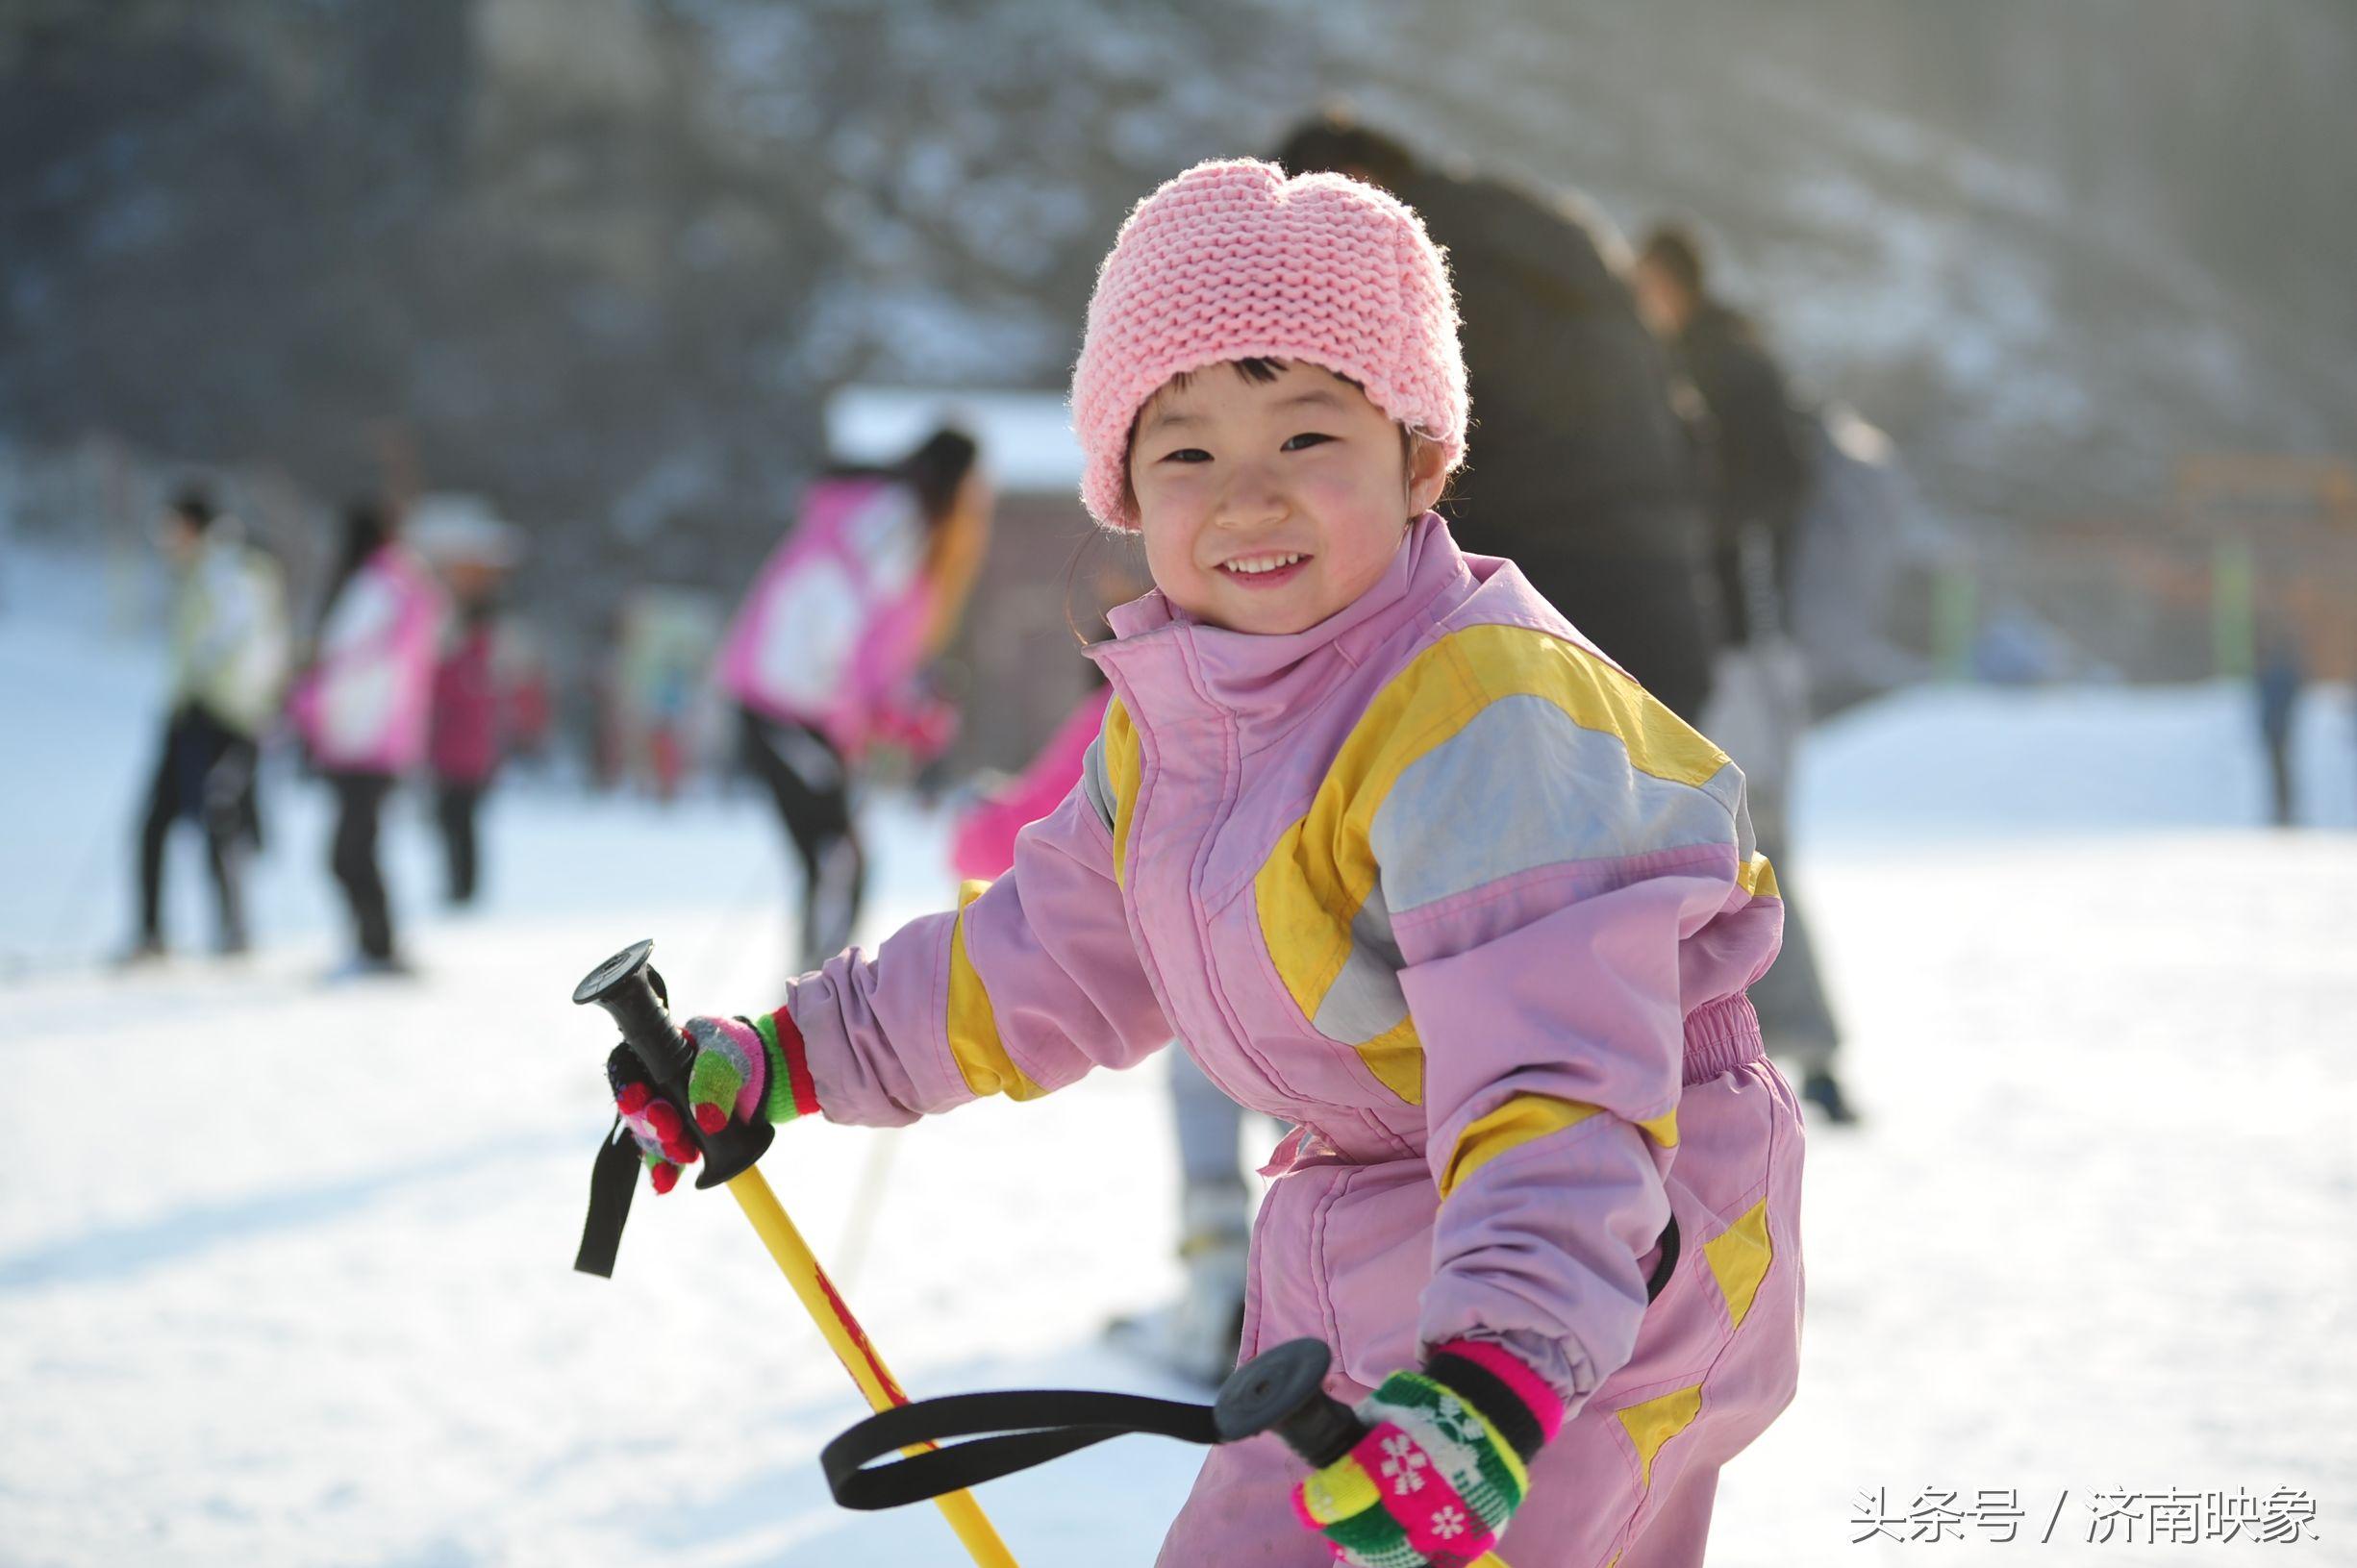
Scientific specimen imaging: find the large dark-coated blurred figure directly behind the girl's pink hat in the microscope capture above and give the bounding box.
[1273,111,1716,724]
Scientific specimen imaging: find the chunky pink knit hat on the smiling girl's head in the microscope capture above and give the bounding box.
[1072,158,1467,528]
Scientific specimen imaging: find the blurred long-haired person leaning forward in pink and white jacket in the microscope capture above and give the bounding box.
[716,429,992,969]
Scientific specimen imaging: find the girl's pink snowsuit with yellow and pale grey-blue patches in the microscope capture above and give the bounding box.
[788,514,1801,1568]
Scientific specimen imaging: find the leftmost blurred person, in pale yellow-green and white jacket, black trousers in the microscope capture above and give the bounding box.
[127,488,288,962]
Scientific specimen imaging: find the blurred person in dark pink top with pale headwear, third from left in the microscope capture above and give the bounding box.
[408,498,516,908]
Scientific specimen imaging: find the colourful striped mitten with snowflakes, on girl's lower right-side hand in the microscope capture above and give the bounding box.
[1294,1339,1563,1568]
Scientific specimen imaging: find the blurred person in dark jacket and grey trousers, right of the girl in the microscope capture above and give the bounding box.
[1631,224,1857,1125]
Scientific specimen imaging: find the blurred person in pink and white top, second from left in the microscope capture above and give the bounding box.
[292,502,443,974]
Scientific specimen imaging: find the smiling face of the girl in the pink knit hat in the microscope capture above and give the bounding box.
[1129,361,1444,635]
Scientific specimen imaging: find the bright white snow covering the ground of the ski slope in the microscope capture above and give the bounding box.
[0,542,2357,1568]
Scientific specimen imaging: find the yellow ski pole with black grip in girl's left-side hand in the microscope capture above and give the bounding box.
[573,941,1016,1568]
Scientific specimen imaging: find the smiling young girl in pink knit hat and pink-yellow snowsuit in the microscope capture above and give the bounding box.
[615,161,1801,1568]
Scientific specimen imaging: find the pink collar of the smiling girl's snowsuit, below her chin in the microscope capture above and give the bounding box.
[1089,511,1473,722]
